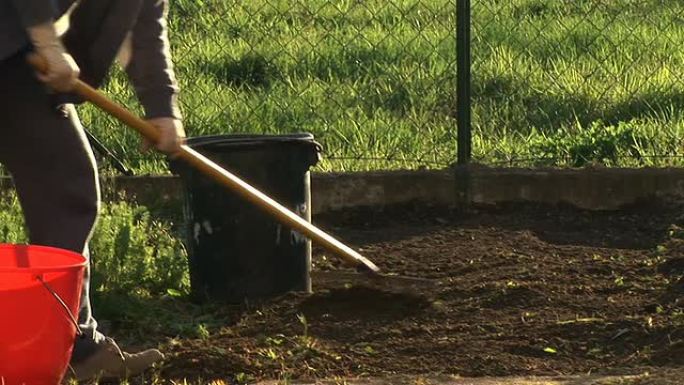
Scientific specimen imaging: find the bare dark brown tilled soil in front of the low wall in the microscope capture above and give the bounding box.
[144,202,684,384]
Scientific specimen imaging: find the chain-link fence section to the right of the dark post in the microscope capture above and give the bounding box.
[471,0,684,167]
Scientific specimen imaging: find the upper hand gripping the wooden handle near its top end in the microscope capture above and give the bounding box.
[27,22,80,92]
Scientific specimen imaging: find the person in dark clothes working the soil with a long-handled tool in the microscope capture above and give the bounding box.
[0,0,185,380]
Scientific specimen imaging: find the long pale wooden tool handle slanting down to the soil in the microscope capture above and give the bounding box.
[28,54,380,273]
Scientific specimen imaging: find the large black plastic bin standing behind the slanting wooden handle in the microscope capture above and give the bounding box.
[171,134,321,303]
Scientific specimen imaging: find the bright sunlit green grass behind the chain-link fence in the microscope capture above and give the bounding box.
[77,0,684,172]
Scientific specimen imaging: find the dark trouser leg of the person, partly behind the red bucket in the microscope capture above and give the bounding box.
[0,49,104,362]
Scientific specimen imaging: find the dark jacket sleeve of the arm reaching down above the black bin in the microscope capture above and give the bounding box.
[123,0,181,119]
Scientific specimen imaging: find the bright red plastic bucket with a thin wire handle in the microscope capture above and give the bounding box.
[0,244,86,385]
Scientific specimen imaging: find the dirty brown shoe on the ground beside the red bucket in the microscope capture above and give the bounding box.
[63,337,164,383]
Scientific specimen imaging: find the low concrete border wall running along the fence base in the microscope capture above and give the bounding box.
[0,166,684,214]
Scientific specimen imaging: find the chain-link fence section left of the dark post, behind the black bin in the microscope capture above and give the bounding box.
[77,0,456,172]
